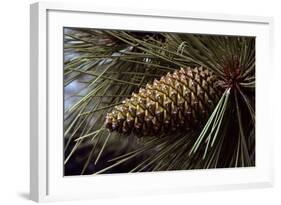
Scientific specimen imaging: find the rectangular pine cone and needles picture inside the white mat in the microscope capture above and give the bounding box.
[64,28,255,175]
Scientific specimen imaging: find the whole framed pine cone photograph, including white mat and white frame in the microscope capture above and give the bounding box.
[30,3,273,201]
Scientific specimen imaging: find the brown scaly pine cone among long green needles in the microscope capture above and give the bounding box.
[105,67,222,136]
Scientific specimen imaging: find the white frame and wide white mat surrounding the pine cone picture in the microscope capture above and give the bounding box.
[30,2,273,202]
